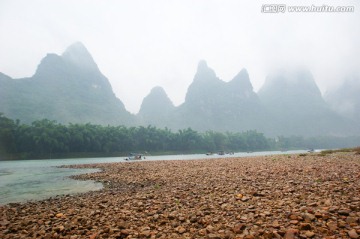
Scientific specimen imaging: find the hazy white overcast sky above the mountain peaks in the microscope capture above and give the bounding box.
[0,0,360,113]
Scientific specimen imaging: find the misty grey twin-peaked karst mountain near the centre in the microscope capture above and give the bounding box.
[172,61,267,131]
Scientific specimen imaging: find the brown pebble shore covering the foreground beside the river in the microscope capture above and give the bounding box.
[0,153,360,239]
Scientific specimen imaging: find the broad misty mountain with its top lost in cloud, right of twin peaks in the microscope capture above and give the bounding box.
[258,69,351,135]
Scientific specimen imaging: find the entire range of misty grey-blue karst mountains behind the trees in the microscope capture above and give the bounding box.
[0,43,360,136]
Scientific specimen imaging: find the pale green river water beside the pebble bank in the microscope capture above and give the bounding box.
[0,150,306,205]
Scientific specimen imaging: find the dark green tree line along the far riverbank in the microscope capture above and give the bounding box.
[0,114,358,158]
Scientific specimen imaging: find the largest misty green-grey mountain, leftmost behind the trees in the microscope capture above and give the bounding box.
[0,43,133,124]
